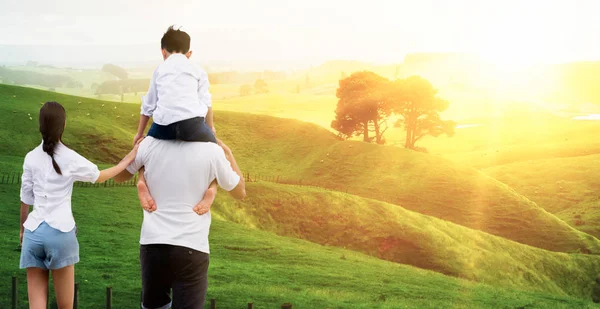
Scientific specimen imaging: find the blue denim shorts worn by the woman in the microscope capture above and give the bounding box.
[20,222,79,269]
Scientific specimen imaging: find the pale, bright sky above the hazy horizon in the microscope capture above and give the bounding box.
[0,0,600,65]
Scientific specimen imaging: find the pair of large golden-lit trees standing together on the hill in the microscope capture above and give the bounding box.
[331,71,456,149]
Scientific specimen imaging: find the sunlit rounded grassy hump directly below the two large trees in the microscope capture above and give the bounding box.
[292,142,600,253]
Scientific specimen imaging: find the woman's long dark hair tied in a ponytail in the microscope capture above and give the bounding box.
[40,102,67,175]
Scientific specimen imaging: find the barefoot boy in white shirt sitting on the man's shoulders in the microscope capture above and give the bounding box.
[133,26,217,215]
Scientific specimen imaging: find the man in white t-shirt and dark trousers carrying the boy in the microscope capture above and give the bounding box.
[115,137,246,309]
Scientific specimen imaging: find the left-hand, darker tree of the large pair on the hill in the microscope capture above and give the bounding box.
[331,71,391,144]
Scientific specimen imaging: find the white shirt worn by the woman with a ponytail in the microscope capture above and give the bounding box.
[21,143,100,232]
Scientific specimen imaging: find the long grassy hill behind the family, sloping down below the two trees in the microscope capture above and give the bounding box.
[0,82,600,253]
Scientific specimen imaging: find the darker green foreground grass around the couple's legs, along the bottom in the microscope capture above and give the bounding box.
[0,185,595,309]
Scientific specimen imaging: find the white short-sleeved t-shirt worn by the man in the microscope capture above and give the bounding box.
[127,136,240,253]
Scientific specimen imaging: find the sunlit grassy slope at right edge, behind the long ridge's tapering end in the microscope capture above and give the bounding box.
[483,155,600,238]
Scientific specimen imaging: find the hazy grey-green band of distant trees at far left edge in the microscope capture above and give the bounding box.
[0,67,77,88]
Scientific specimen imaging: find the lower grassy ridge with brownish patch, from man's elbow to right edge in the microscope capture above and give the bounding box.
[213,182,600,297]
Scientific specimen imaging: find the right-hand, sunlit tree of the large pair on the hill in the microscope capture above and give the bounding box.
[388,76,456,149]
